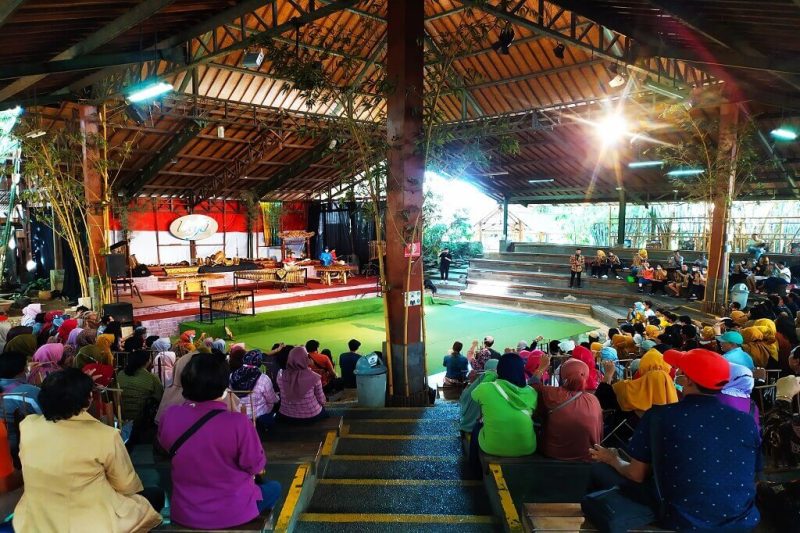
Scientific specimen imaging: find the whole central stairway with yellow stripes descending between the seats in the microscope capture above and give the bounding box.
[295,403,502,533]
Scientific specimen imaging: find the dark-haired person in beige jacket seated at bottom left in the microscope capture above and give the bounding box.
[14,369,163,532]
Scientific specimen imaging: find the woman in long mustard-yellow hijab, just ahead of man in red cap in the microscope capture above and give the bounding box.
[611,348,678,417]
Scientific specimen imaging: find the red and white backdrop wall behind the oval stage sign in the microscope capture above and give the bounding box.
[111,198,308,265]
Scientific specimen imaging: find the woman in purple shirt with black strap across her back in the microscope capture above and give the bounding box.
[158,354,281,529]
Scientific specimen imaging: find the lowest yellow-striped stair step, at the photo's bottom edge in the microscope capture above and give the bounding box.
[295,513,496,533]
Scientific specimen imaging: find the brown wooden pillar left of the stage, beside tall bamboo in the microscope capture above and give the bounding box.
[79,105,106,276]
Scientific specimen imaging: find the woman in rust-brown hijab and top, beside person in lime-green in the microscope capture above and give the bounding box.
[533,359,603,462]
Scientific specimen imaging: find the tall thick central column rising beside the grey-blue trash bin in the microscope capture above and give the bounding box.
[385,0,427,405]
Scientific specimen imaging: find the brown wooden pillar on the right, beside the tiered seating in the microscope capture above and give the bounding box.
[703,103,739,313]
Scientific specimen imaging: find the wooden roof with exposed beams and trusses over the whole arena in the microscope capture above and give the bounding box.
[0,0,800,203]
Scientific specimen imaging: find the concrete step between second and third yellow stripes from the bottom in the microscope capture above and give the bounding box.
[325,455,472,479]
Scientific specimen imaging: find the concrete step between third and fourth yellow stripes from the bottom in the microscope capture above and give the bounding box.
[336,434,462,457]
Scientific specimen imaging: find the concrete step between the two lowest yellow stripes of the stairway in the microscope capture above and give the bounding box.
[306,478,492,520]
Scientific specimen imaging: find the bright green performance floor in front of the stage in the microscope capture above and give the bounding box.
[181,298,594,374]
